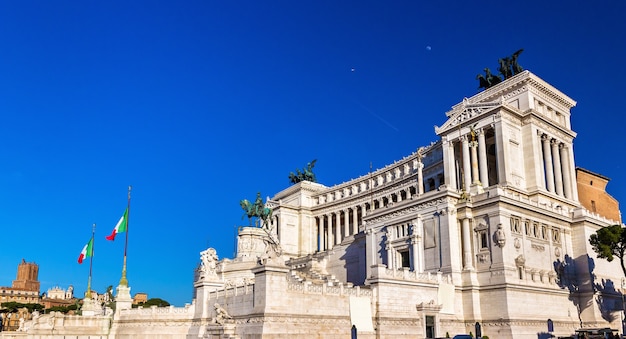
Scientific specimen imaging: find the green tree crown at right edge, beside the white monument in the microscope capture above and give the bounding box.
[589,225,626,276]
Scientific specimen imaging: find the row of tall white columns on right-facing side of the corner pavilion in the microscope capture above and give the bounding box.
[540,133,574,199]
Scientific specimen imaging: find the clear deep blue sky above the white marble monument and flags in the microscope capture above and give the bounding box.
[0,0,626,305]
